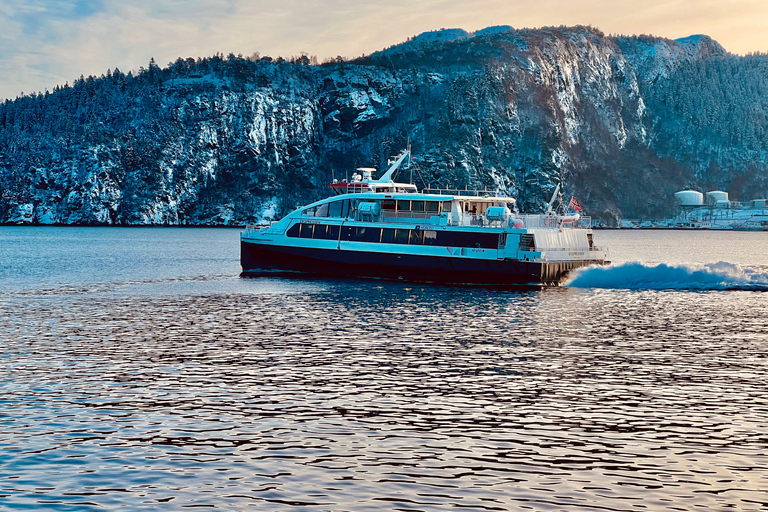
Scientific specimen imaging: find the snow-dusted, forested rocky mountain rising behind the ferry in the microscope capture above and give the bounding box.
[0,26,768,225]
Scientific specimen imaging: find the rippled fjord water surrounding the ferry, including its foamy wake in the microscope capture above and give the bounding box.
[0,227,768,511]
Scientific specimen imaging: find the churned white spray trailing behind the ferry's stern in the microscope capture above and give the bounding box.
[567,261,768,291]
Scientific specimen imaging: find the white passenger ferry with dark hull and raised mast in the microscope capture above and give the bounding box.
[240,150,607,286]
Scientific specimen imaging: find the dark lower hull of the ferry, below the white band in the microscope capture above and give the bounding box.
[240,241,600,284]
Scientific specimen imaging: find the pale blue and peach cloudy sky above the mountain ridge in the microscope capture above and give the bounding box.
[0,0,768,101]
